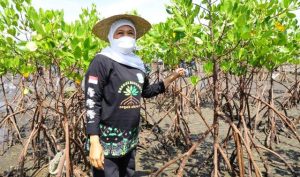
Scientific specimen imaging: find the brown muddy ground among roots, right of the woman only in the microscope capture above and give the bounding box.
[137,104,300,177]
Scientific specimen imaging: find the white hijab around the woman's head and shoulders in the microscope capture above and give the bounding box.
[99,19,146,72]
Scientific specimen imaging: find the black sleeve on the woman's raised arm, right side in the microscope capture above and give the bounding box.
[142,77,165,98]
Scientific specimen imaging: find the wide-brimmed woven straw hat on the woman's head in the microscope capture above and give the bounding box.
[93,14,151,42]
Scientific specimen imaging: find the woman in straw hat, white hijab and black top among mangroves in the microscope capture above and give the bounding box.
[85,15,184,177]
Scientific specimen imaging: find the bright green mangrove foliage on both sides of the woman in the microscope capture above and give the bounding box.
[0,0,300,80]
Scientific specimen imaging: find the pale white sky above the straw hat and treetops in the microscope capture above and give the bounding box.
[32,0,300,24]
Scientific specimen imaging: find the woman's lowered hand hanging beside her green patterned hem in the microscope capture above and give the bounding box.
[89,135,104,170]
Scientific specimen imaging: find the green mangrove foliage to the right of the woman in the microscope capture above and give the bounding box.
[140,0,300,75]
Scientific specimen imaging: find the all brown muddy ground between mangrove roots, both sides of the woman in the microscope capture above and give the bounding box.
[0,71,300,177]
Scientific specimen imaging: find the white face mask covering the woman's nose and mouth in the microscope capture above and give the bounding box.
[111,36,135,54]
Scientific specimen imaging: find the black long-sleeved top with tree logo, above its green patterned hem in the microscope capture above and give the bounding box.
[85,54,165,134]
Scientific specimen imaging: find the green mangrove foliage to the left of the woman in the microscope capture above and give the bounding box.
[0,0,105,80]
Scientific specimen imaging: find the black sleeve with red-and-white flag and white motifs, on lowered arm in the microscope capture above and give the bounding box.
[84,56,108,135]
